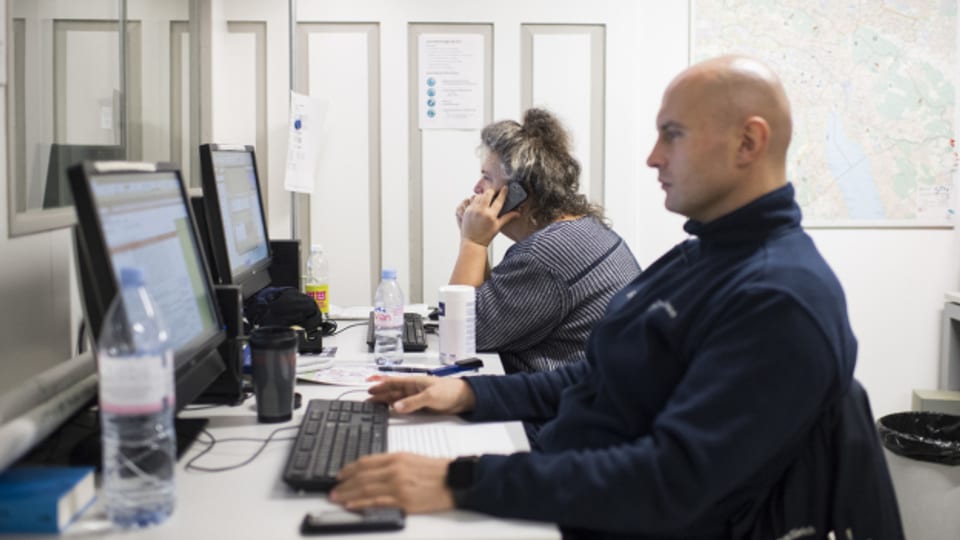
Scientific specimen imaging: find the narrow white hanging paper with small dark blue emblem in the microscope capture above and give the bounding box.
[283,91,327,193]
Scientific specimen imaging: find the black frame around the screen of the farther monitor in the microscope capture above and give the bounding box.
[200,143,273,299]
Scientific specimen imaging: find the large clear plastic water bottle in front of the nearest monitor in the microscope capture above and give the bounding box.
[97,268,176,528]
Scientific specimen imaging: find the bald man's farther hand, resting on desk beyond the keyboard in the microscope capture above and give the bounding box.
[369,377,476,414]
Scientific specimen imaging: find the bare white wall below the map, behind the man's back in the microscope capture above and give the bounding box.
[810,229,960,417]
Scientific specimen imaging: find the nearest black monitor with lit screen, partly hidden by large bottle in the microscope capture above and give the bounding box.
[69,162,225,410]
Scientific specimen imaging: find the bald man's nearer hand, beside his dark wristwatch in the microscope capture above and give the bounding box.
[330,452,453,514]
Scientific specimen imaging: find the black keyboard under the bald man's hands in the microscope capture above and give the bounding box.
[283,399,389,491]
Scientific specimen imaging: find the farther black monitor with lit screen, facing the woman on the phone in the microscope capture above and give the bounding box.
[200,144,273,299]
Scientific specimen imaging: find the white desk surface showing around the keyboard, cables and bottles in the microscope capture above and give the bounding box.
[18,324,560,540]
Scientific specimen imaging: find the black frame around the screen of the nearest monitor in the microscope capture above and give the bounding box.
[68,161,226,411]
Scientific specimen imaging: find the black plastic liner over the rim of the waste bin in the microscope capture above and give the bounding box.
[877,412,960,465]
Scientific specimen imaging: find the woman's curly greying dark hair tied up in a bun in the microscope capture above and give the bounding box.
[480,109,605,228]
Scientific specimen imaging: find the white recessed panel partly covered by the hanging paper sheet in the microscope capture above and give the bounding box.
[297,23,378,305]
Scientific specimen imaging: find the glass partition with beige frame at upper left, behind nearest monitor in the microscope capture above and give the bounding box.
[7,0,196,236]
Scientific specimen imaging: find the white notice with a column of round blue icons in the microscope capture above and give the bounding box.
[417,34,484,129]
